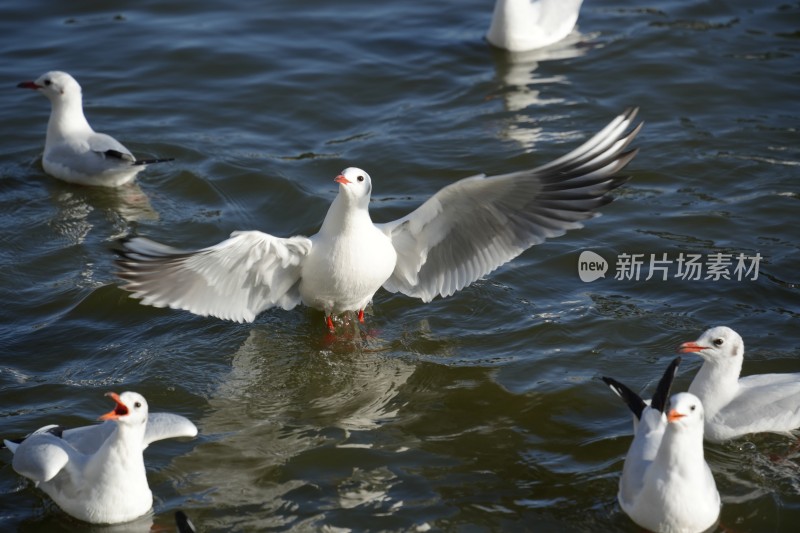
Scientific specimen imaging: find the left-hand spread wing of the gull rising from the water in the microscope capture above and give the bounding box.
[117,231,311,322]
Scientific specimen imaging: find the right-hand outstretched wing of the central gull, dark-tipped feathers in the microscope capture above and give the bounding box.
[377,109,641,302]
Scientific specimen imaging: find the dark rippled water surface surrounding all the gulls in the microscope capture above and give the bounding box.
[0,0,800,532]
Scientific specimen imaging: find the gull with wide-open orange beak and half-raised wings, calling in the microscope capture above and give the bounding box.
[5,392,197,524]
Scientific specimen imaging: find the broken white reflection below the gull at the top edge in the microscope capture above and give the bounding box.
[493,29,596,152]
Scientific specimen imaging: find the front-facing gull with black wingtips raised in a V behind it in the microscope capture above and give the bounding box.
[603,358,721,533]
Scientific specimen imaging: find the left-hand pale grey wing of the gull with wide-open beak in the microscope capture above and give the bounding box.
[11,432,76,483]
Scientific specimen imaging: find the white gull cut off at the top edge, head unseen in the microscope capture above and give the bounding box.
[486,0,583,52]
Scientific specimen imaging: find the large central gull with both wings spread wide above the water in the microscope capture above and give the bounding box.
[117,109,642,330]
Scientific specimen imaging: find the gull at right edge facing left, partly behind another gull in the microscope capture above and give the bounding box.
[680,326,800,442]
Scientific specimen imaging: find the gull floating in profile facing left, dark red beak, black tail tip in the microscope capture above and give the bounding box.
[17,70,172,187]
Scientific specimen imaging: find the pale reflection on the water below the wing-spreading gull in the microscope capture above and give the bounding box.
[178,321,415,529]
